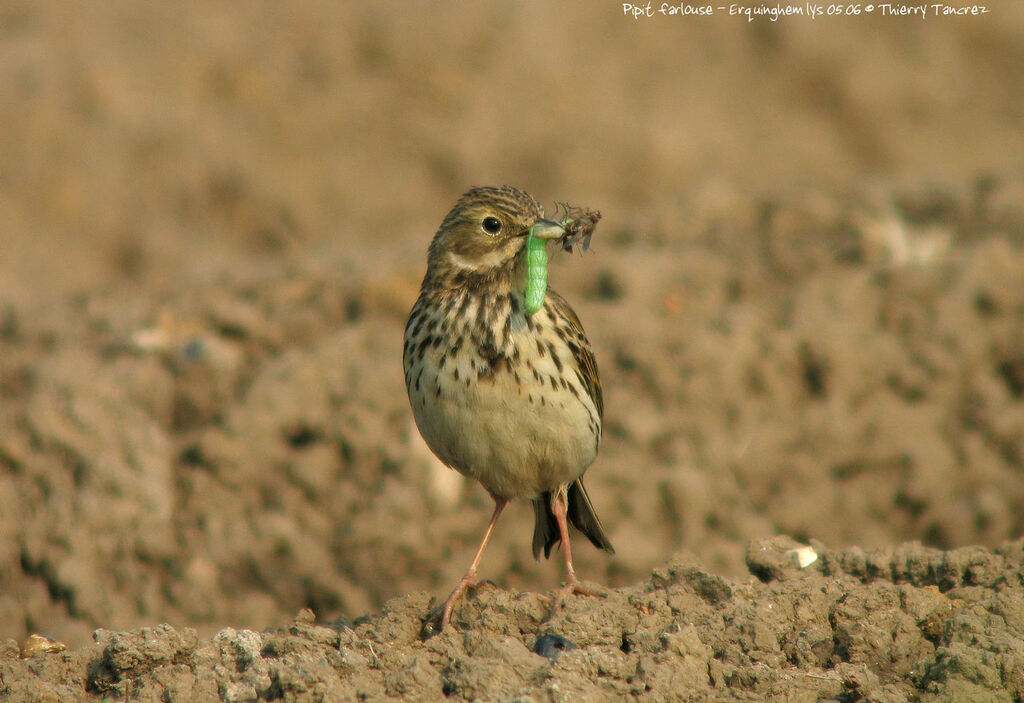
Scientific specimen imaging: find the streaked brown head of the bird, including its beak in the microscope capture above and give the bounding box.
[427,185,565,281]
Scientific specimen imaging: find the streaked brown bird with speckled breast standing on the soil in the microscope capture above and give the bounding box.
[402,185,614,631]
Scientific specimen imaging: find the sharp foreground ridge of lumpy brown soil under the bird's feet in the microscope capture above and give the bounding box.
[8,537,1024,703]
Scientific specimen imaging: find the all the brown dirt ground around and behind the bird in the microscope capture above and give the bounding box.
[0,1,1024,703]
